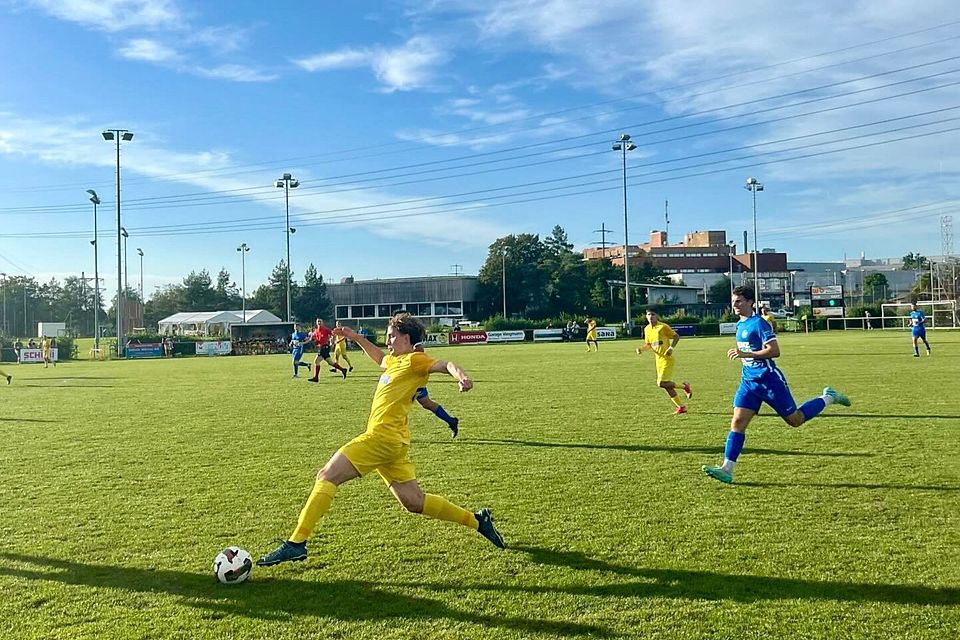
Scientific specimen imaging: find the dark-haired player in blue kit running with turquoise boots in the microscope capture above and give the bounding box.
[702,287,850,484]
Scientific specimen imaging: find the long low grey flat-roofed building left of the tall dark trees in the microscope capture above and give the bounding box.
[327,276,478,326]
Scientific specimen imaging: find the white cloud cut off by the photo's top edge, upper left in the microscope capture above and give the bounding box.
[32,0,181,31]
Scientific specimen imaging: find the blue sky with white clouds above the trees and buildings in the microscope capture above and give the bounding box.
[0,0,960,296]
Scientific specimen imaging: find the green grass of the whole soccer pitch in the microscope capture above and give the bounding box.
[0,331,960,639]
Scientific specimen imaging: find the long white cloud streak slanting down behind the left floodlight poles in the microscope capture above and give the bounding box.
[0,112,507,247]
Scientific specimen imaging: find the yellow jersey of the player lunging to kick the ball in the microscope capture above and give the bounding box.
[367,351,437,444]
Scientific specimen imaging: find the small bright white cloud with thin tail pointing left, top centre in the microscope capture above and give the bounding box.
[292,36,448,91]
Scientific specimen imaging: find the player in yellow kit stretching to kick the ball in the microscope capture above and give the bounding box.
[257,313,506,567]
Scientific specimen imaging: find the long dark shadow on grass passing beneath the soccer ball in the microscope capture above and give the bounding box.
[0,553,610,637]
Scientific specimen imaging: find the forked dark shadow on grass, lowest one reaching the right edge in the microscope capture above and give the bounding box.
[396,545,960,607]
